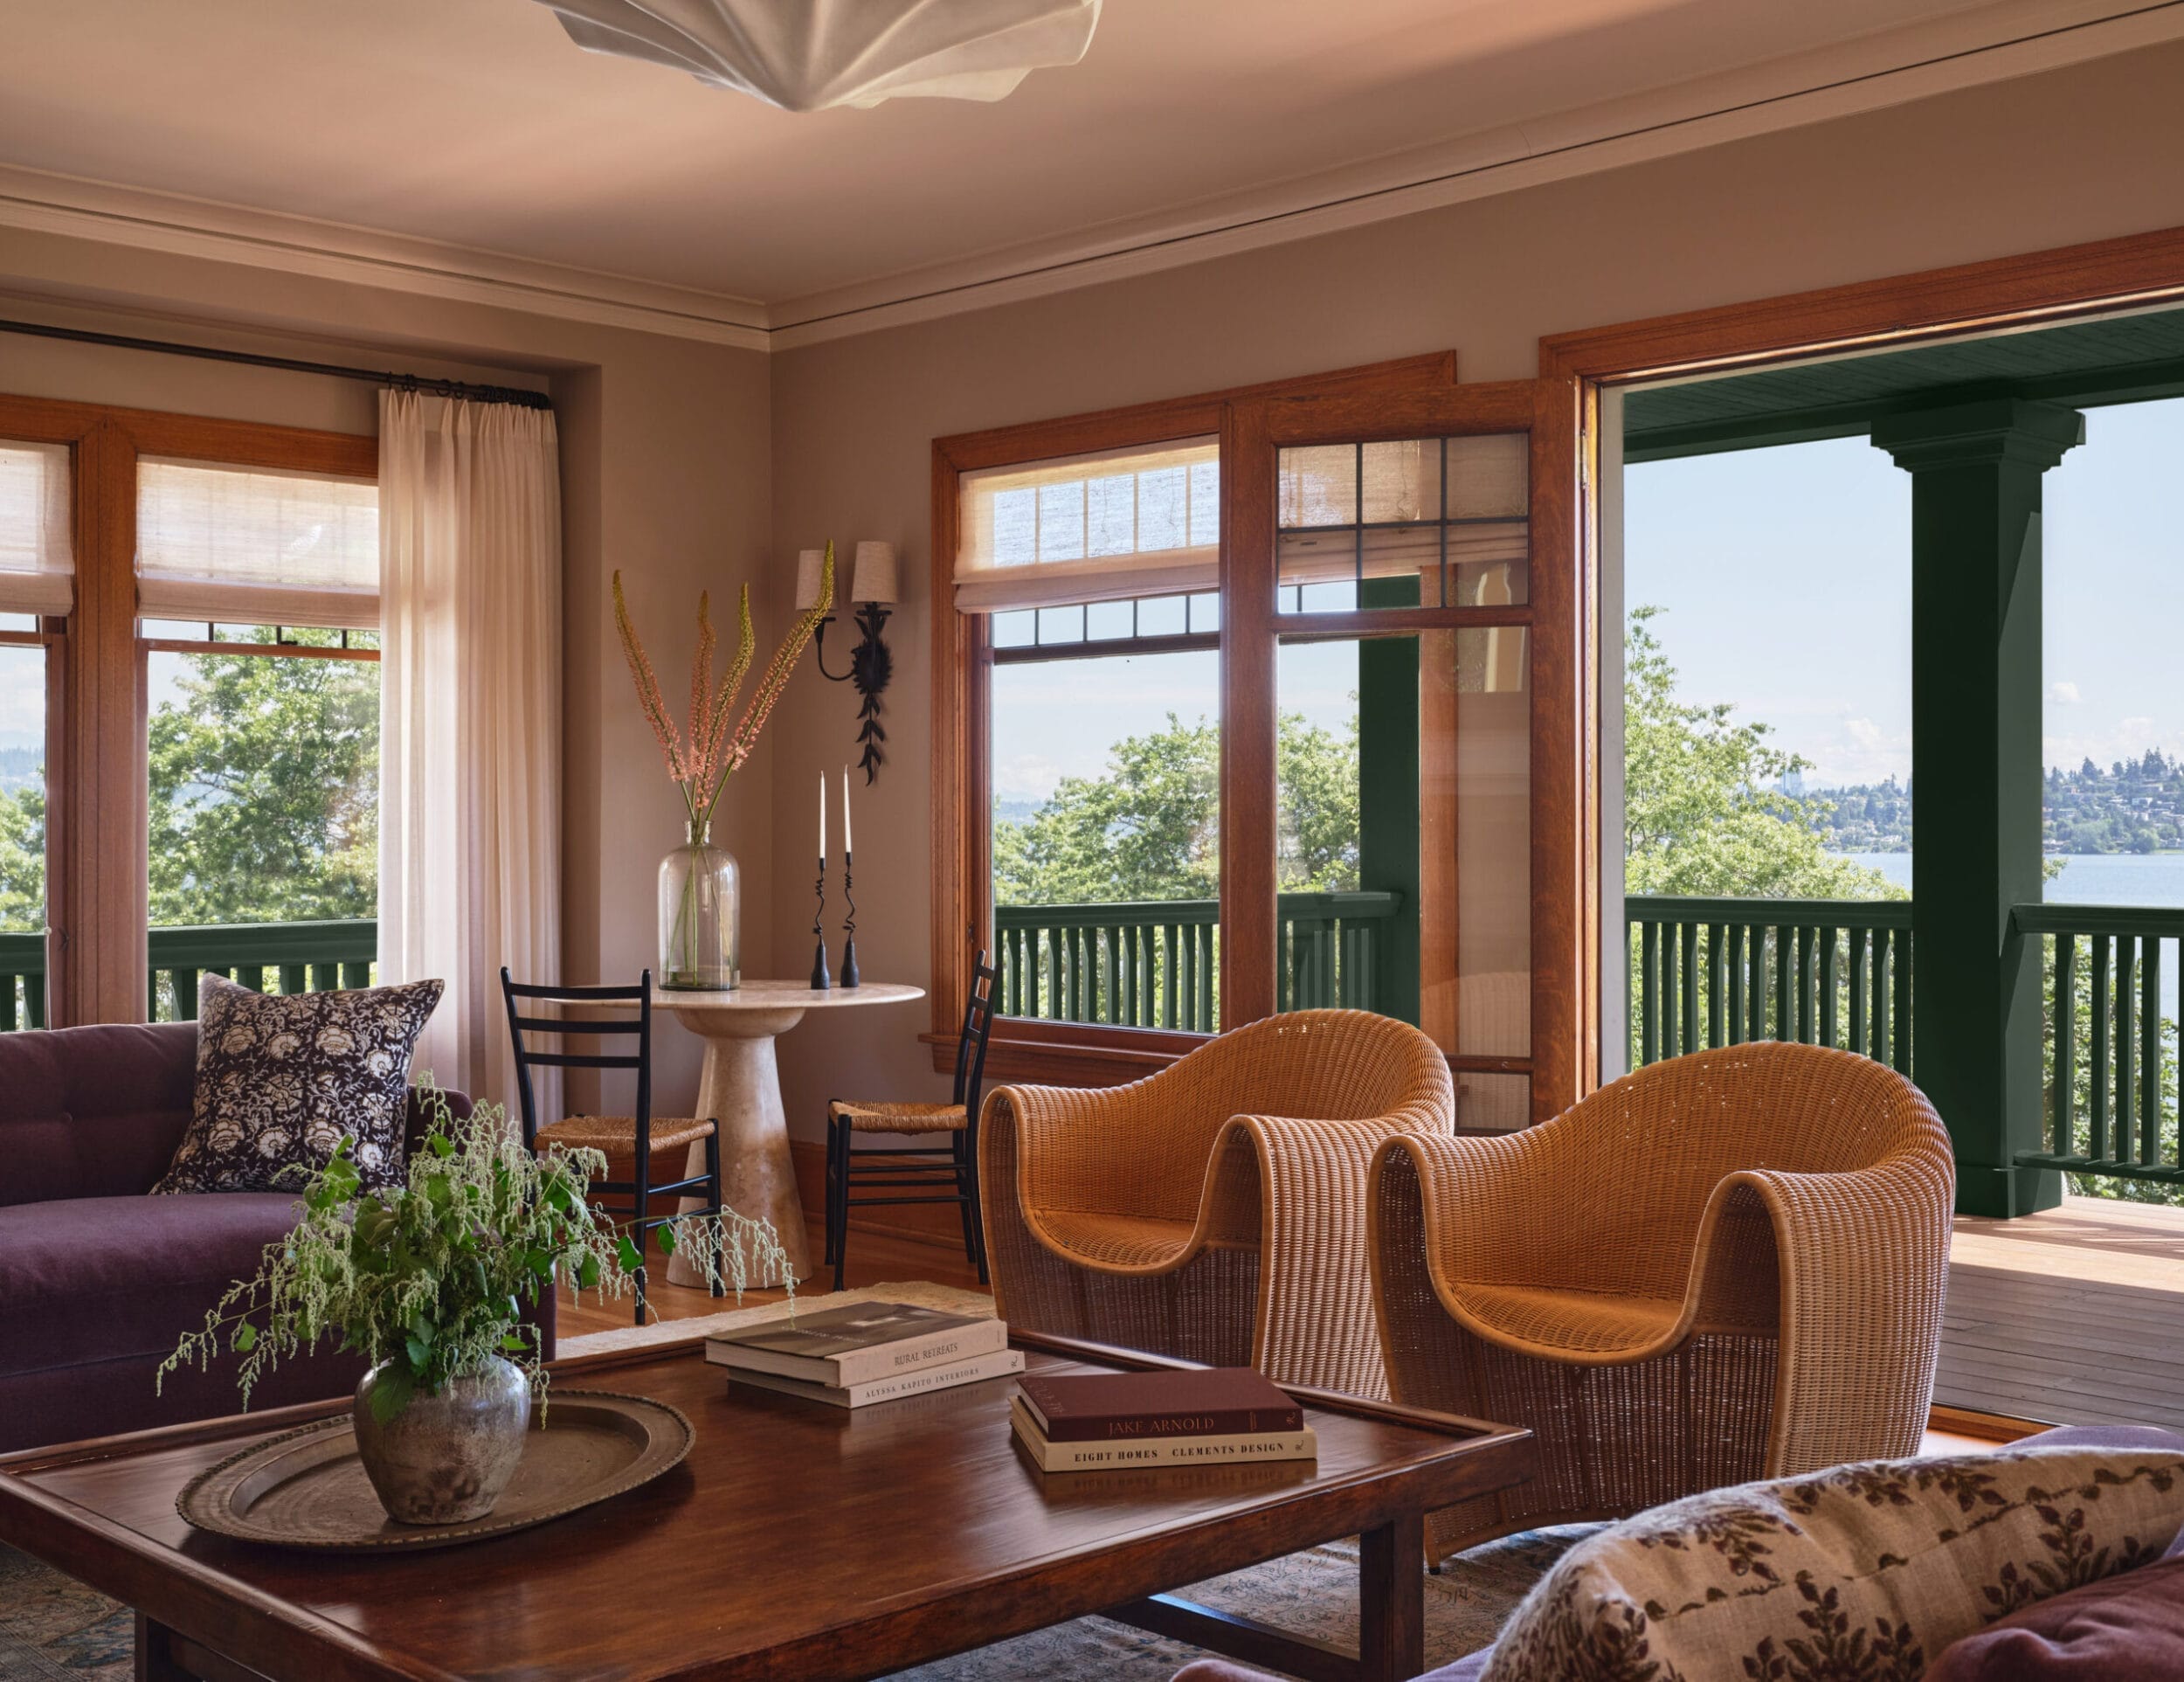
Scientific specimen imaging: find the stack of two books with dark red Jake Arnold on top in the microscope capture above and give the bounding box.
[1009,1367,1319,1472]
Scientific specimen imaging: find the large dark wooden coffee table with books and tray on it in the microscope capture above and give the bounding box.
[0,1335,1536,1682]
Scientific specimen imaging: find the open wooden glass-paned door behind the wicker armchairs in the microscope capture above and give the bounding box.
[1221,380,1588,1130]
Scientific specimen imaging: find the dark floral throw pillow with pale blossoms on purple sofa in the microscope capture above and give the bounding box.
[153,974,441,1193]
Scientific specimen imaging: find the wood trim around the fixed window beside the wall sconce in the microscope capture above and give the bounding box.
[924,352,1457,1086]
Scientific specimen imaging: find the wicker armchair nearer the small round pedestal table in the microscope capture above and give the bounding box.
[978,1012,1455,1396]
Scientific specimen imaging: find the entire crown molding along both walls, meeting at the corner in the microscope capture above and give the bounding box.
[0,0,2184,352]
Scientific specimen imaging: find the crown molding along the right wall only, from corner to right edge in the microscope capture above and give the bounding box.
[769,0,2184,350]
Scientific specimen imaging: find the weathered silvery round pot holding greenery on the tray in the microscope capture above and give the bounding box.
[356,1357,531,1525]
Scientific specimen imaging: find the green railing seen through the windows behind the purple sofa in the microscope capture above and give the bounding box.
[0,917,380,1031]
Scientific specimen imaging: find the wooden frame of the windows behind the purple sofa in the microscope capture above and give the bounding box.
[0,396,380,1027]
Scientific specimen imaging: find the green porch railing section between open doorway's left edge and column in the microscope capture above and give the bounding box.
[1623,894,1911,1073]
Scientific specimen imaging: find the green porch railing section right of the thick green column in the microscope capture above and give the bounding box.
[2009,904,2184,1184]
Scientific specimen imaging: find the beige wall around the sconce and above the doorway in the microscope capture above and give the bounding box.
[773,46,2184,1136]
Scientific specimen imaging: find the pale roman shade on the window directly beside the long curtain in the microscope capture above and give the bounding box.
[138,457,380,632]
